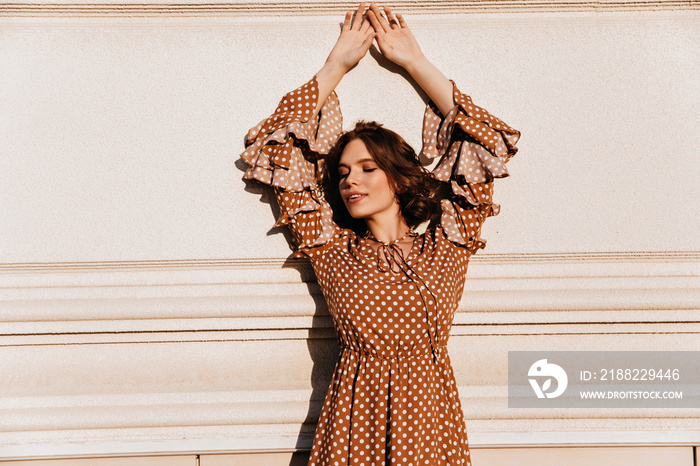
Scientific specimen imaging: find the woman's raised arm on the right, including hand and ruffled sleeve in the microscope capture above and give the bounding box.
[367,4,520,253]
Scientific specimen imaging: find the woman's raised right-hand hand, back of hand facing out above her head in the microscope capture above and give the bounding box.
[367,3,425,71]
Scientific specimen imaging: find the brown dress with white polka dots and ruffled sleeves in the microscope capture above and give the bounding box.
[242,77,520,466]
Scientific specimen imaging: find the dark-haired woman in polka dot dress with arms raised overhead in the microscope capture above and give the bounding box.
[242,4,519,465]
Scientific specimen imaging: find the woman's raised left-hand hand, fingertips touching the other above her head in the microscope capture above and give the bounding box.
[326,3,375,73]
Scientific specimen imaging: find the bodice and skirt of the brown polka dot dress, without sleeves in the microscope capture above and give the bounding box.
[309,228,471,466]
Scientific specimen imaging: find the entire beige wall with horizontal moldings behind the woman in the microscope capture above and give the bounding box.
[0,1,700,465]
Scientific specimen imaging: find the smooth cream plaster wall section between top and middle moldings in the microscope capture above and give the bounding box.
[0,11,700,263]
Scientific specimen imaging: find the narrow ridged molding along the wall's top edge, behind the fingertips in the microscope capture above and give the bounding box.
[0,0,700,17]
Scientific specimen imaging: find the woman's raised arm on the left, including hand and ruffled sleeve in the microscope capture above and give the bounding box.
[241,4,374,257]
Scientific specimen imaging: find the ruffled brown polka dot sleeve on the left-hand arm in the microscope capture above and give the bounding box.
[241,76,342,257]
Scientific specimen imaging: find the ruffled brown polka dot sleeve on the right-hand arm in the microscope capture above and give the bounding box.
[422,82,520,253]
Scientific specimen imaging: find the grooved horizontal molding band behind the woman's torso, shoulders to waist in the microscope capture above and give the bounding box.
[0,252,700,346]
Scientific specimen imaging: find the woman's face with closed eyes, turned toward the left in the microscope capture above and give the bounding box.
[338,139,401,222]
